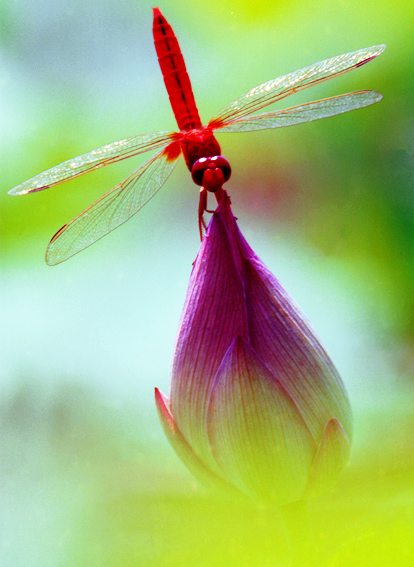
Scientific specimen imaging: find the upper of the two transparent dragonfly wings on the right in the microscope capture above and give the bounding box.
[209,45,386,128]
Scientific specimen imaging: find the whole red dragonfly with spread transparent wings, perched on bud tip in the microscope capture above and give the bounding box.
[9,8,385,265]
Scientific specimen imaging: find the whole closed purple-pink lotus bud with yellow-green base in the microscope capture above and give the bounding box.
[155,193,351,505]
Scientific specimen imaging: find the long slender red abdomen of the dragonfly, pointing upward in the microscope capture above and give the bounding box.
[153,8,201,131]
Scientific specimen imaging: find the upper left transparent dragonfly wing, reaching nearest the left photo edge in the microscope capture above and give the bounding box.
[9,132,175,195]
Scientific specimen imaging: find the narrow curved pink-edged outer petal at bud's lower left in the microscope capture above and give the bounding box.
[155,388,238,492]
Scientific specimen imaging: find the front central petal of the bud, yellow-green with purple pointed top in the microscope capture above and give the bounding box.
[207,337,316,505]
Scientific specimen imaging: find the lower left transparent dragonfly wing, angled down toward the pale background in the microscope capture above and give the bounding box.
[46,149,179,266]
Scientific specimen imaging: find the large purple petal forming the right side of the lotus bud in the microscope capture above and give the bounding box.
[243,255,352,443]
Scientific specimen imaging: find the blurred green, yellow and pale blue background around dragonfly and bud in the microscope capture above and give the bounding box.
[0,0,414,567]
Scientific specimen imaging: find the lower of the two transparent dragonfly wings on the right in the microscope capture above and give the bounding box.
[210,91,382,132]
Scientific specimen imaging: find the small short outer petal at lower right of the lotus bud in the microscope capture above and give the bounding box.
[308,418,350,496]
